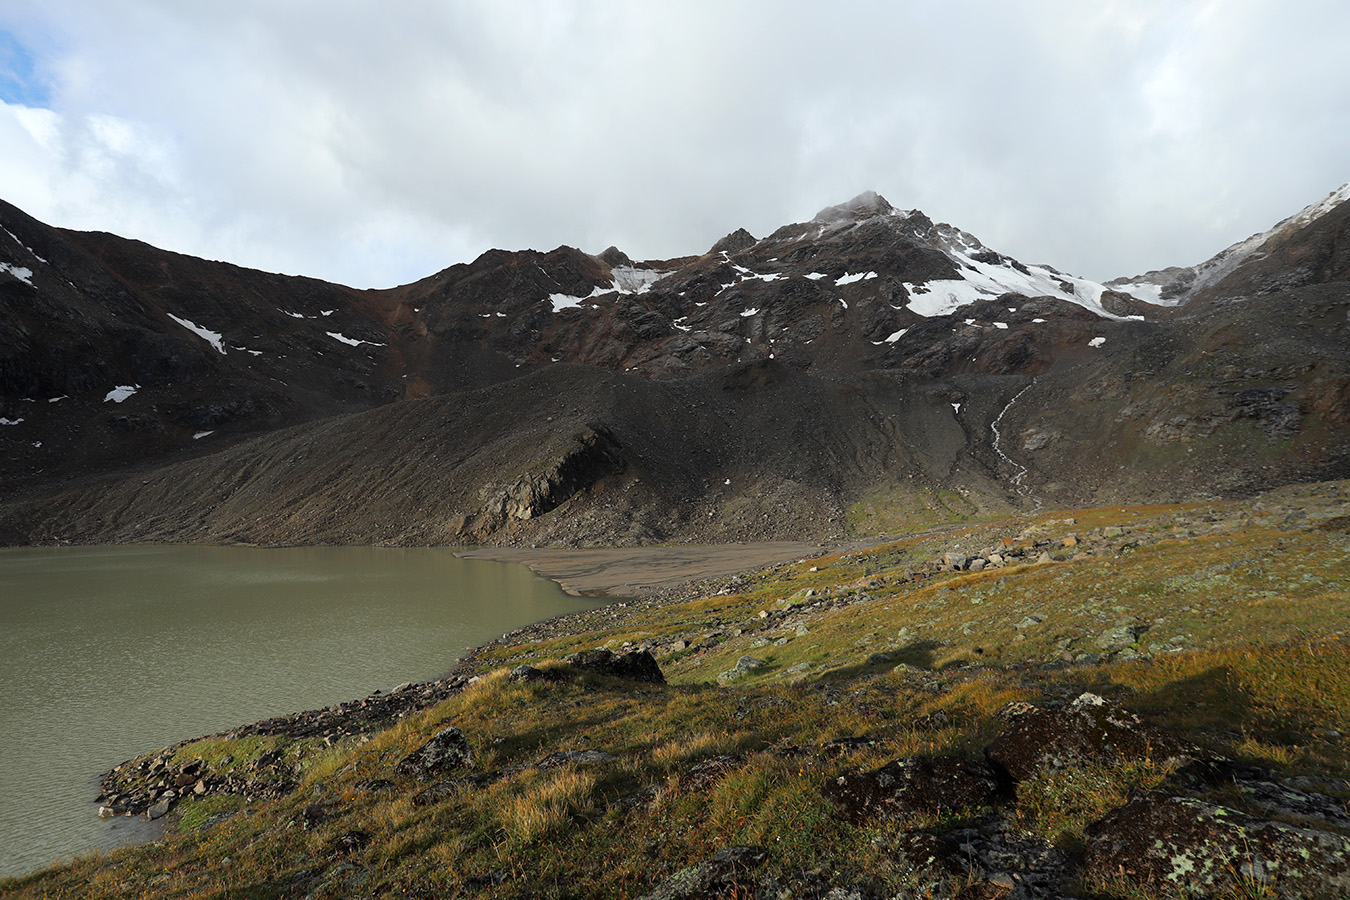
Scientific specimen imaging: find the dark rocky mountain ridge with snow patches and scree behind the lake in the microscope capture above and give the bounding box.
[0,188,1350,544]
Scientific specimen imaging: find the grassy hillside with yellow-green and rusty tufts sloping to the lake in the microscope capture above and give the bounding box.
[0,482,1350,899]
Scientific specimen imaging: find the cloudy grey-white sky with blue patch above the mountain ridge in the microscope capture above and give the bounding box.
[0,0,1350,287]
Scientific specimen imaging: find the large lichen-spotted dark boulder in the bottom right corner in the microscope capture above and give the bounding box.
[1084,792,1350,900]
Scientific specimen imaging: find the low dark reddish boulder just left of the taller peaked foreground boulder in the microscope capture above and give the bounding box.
[821,756,999,824]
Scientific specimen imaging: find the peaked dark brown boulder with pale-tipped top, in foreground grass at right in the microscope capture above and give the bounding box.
[984,694,1196,781]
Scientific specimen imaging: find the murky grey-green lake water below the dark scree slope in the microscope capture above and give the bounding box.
[0,546,597,876]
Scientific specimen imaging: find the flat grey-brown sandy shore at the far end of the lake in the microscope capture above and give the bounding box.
[459,541,830,596]
